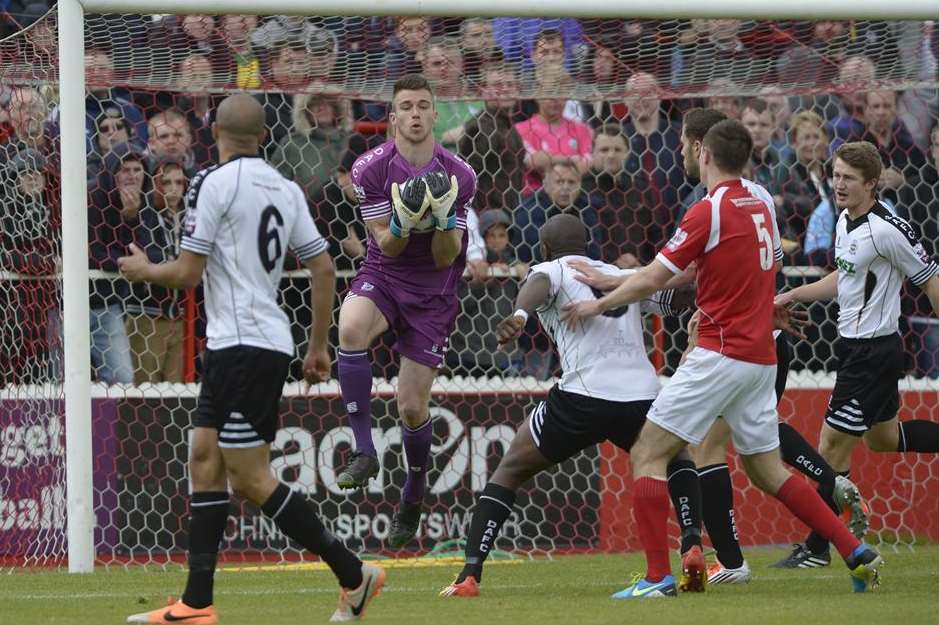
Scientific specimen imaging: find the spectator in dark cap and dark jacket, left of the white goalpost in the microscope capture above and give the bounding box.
[0,148,59,388]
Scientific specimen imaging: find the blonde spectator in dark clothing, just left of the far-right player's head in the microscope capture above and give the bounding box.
[774,111,833,241]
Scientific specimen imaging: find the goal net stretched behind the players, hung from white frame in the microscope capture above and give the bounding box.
[0,6,939,566]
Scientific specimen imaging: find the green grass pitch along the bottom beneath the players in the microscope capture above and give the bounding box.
[0,545,939,625]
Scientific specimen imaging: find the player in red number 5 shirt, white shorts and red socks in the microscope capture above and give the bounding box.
[564,120,883,599]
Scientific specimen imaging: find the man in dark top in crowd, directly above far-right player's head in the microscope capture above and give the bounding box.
[861,91,926,205]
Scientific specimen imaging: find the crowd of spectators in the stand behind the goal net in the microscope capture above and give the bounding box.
[0,9,939,384]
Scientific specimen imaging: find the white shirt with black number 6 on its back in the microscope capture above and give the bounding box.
[180,156,328,355]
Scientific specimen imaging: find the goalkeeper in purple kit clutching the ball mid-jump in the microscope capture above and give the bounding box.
[337,74,476,548]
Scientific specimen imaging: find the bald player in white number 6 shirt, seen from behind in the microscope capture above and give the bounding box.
[118,95,385,625]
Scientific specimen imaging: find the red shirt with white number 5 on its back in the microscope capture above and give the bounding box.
[656,178,782,365]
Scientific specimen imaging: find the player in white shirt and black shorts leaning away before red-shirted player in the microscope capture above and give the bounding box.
[440,215,701,597]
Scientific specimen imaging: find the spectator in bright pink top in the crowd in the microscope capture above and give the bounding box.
[515,76,593,195]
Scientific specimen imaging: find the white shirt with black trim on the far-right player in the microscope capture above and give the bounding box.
[835,202,939,339]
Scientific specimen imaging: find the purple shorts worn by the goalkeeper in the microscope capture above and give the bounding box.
[346,273,460,369]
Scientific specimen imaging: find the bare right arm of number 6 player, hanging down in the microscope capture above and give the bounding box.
[303,252,336,384]
